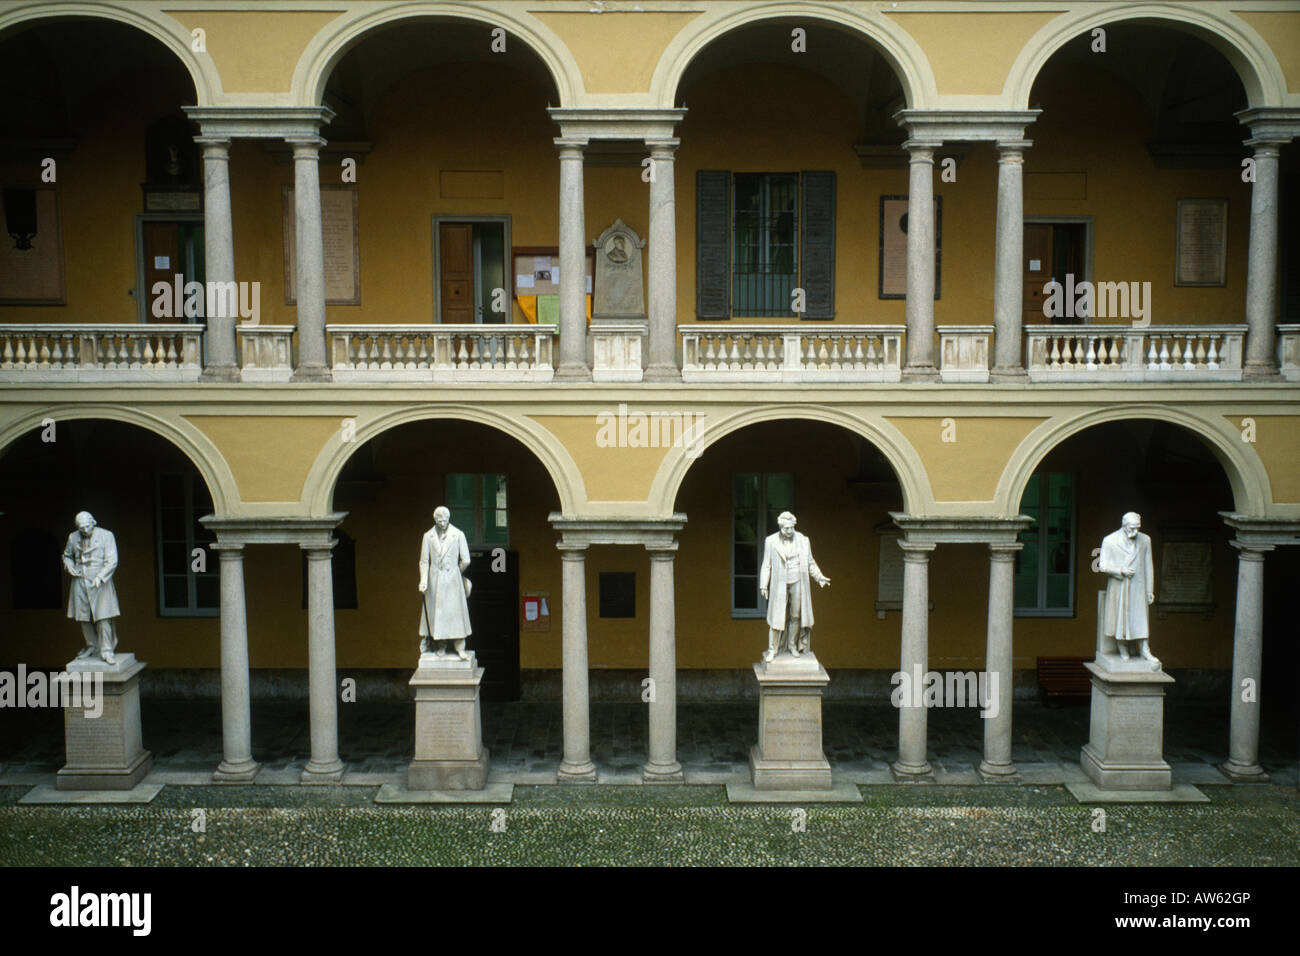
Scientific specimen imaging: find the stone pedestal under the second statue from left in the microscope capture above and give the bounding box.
[407,652,488,790]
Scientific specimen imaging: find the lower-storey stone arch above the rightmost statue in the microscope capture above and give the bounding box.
[995,405,1271,515]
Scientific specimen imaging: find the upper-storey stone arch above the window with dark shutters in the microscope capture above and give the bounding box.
[650,0,937,109]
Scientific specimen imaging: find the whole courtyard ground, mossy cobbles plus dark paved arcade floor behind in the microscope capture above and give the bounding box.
[0,700,1300,866]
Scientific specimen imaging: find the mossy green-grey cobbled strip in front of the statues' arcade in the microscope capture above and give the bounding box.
[0,786,1300,866]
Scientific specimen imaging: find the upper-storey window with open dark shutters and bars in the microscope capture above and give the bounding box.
[696,169,835,319]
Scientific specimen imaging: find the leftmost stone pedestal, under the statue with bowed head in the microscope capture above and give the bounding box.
[55,654,153,790]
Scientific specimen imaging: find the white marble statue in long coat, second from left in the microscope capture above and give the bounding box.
[420,506,469,661]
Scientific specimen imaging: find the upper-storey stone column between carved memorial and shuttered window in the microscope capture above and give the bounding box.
[645,139,681,381]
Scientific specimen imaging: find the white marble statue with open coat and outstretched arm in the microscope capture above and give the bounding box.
[758,511,831,663]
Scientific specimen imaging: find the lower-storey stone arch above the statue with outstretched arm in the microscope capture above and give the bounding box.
[649,405,935,516]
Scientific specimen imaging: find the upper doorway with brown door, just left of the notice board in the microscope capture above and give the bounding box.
[433,216,512,325]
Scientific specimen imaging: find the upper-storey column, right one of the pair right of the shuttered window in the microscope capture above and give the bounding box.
[987,139,1031,381]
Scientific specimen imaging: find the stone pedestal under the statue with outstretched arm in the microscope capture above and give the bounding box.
[749,653,832,790]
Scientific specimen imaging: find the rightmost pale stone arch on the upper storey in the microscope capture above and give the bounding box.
[1002,3,1287,109]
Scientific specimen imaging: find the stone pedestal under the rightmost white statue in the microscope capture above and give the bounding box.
[1079,654,1174,790]
